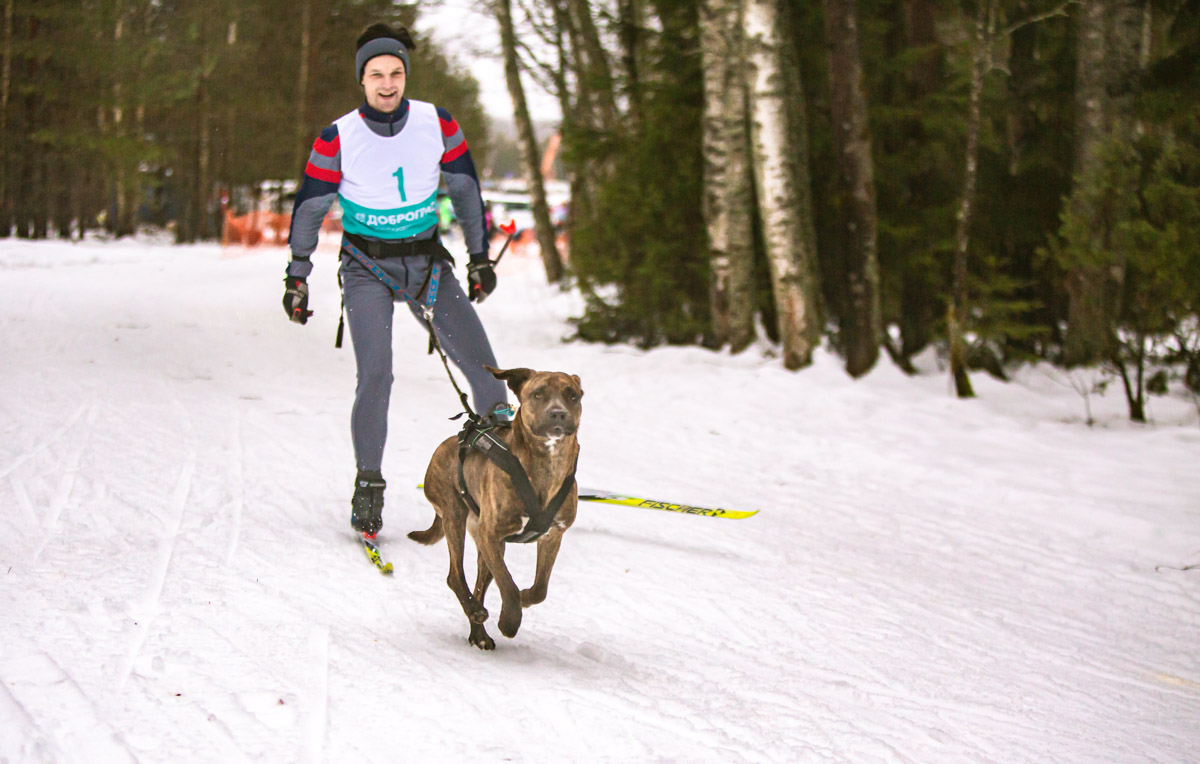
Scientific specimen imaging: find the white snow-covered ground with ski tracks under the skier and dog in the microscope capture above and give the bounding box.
[0,235,1200,763]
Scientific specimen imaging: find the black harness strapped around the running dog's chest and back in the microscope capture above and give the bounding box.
[458,416,580,543]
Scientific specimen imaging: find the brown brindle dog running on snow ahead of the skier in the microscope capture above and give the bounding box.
[408,366,583,650]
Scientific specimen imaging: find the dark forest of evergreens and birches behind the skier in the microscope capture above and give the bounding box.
[0,0,1200,421]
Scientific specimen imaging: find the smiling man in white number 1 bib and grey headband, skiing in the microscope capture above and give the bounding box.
[283,24,508,539]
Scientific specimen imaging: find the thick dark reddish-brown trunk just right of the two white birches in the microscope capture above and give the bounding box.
[824,0,883,377]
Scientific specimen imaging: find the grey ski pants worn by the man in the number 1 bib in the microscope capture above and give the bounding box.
[341,252,508,471]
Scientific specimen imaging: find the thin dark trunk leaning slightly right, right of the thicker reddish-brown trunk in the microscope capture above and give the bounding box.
[946,0,992,398]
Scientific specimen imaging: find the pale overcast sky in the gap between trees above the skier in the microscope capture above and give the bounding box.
[416,0,560,120]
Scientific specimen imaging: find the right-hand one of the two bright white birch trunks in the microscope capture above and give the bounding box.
[744,0,820,369]
